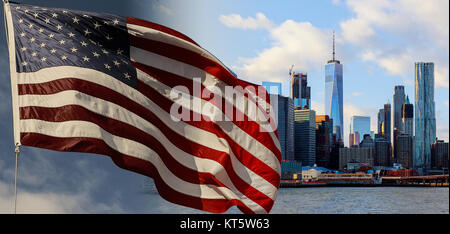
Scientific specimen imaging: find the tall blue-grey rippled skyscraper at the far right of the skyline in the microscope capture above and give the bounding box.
[414,62,436,168]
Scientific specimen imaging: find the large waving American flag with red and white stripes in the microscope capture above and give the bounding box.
[5,3,281,213]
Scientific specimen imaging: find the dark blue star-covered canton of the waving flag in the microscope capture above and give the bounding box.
[11,5,137,88]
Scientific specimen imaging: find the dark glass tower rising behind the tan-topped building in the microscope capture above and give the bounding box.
[291,72,311,109]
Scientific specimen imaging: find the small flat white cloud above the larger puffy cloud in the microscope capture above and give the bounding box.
[219,13,274,29]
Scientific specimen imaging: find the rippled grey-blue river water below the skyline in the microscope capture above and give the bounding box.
[142,183,449,214]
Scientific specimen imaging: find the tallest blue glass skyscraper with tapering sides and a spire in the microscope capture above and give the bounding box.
[325,32,344,141]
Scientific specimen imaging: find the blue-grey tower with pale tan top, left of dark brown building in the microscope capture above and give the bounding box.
[294,109,316,166]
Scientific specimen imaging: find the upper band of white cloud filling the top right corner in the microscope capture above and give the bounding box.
[341,0,449,47]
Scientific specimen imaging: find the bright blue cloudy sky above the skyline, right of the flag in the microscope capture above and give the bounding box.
[153,0,449,144]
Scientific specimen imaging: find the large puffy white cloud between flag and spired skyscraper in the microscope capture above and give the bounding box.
[229,20,332,84]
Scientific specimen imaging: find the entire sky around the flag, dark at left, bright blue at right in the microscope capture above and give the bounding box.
[0,0,449,213]
